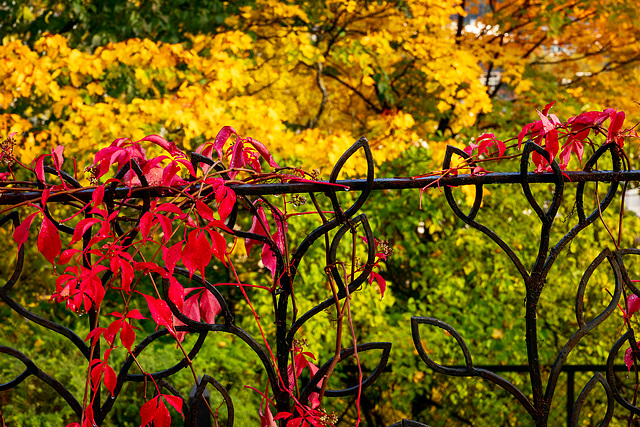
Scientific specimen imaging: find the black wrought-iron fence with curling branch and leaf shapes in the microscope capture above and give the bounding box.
[0,138,640,427]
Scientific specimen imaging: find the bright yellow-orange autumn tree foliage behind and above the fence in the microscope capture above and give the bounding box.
[0,0,640,175]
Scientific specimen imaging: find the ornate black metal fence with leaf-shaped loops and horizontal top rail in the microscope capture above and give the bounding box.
[0,139,640,426]
